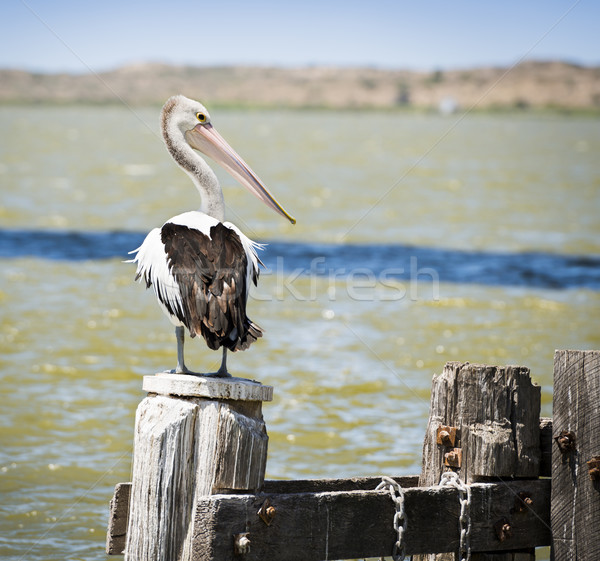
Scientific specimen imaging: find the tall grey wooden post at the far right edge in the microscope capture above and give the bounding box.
[551,351,600,561]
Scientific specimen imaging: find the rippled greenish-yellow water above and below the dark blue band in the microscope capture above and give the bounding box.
[0,107,600,561]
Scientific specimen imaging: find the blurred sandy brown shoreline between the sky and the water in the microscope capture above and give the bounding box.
[0,61,600,114]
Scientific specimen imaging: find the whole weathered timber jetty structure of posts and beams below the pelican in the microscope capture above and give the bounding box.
[107,351,600,561]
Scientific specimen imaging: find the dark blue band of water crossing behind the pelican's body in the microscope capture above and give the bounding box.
[0,229,600,290]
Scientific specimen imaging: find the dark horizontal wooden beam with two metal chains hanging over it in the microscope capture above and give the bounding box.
[193,480,551,561]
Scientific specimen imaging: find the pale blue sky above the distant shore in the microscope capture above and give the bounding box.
[0,0,600,73]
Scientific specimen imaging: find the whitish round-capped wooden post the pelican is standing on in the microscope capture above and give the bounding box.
[125,373,273,561]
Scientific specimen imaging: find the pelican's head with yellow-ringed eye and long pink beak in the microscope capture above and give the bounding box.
[161,95,296,224]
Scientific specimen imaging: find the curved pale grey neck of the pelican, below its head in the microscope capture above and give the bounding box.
[163,124,225,222]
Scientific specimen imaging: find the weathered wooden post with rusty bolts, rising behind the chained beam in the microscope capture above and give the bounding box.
[418,362,541,561]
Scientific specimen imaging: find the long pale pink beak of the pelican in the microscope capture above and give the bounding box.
[185,124,296,224]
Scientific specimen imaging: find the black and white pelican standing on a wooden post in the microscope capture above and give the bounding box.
[130,95,296,376]
